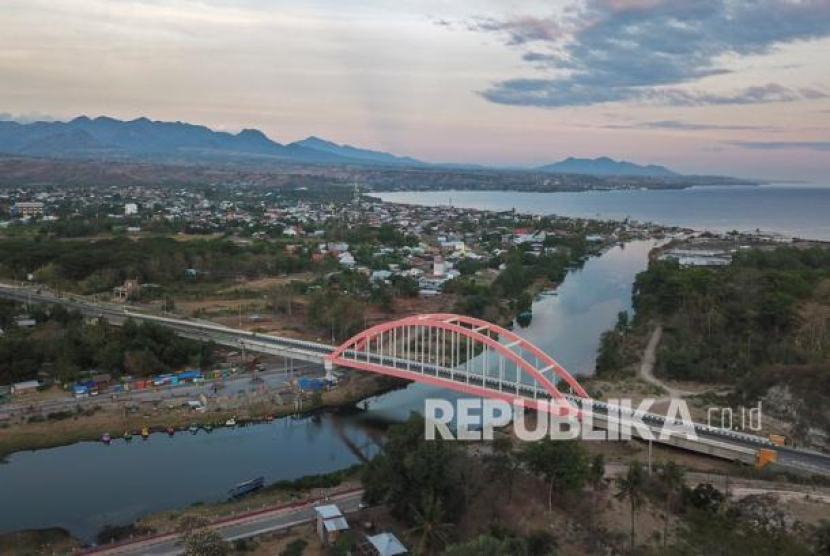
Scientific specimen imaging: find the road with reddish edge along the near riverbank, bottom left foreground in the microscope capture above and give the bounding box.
[79,489,363,556]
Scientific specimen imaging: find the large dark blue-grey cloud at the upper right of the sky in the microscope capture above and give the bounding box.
[470,0,830,107]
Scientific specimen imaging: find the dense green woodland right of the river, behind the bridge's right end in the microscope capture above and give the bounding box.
[597,247,830,432]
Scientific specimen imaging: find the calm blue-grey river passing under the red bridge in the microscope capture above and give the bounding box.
[0,241,652,541]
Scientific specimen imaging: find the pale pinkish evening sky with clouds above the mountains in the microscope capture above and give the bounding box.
[0,0,830,184]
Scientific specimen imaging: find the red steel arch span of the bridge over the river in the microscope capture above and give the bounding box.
[325,313,589,413]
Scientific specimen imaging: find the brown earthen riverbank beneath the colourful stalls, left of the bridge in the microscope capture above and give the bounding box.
[0,371,401,459]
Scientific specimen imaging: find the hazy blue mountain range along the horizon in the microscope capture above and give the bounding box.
[0,116,679,178]
